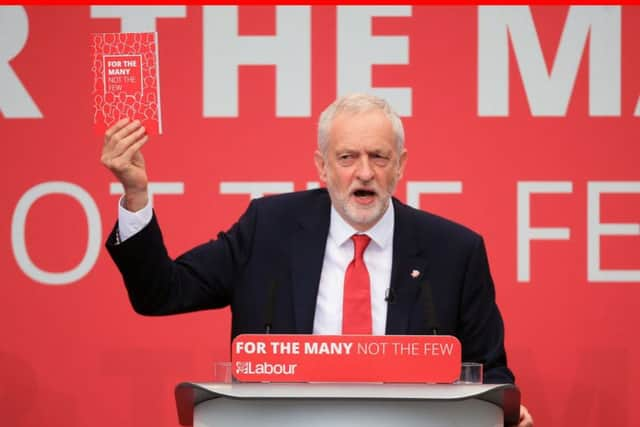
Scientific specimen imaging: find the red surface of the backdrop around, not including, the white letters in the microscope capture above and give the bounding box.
[0,6,640,426]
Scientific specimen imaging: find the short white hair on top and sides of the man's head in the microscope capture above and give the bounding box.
[318,93,404,155]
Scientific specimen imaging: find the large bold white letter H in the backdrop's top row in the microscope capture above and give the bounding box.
[202,6,311,117]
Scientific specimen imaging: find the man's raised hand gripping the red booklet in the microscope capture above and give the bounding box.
[100,118,149,212]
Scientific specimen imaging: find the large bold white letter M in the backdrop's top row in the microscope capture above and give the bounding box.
[478,6,621,116]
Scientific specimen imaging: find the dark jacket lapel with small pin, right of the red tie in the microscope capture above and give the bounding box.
[386,199,427,335]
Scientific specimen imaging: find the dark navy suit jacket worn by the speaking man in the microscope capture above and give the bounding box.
[107,189,514,383]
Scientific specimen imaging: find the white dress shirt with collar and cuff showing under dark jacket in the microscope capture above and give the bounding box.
[118,199,394,335]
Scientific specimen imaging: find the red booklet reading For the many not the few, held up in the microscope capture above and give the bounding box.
[89,32,162,135]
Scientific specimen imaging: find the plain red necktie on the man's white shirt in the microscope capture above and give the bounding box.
[342,234,371,334]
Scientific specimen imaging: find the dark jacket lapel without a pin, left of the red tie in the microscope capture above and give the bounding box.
[291,195,331,334]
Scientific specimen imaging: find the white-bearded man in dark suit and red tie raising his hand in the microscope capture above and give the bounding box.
[102,95,532,426]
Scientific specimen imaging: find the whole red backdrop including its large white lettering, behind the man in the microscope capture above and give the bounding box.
[0,5,640,427]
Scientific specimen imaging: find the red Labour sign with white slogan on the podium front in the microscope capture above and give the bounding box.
[231,334,461,383]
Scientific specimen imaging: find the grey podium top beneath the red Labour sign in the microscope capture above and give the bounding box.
[175,382,520,427]
